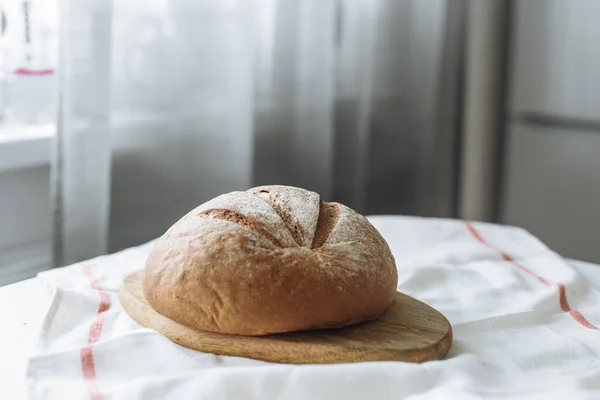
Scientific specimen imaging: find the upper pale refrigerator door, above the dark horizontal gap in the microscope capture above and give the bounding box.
[510,0,600,121]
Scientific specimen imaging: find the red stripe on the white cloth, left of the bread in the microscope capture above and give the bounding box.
[81,265,110,400]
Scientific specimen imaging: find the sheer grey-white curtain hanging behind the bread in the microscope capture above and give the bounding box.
[52,0,463,265]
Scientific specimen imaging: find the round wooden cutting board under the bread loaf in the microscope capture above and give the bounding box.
[119,271,452,364]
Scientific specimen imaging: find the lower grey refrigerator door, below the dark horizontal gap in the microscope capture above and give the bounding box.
[502,125,600,262]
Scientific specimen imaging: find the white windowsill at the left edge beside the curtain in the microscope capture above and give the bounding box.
[0,124,56,172]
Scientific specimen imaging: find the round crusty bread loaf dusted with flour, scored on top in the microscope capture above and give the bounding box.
[143,186,398,335]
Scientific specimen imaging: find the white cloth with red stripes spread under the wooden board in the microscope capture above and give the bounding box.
[8,217,600,399]
